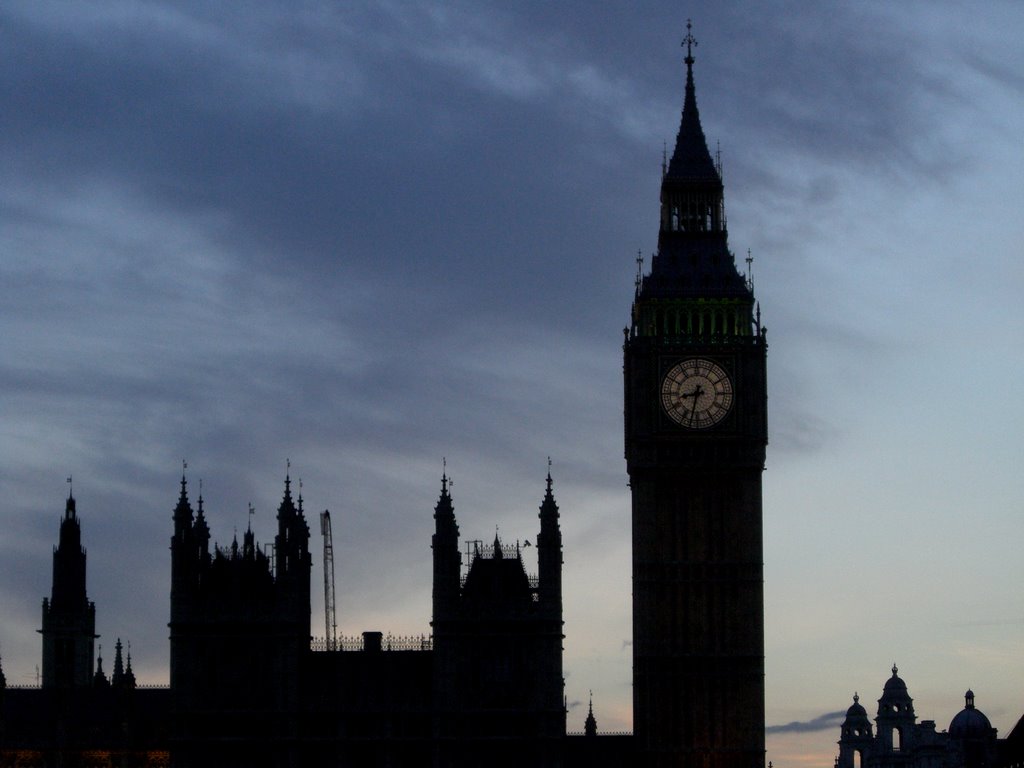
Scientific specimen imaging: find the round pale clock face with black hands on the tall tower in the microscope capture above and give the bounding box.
[662,357,732,429]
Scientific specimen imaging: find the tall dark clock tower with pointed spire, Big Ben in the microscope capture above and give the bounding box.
[624,24,768,768]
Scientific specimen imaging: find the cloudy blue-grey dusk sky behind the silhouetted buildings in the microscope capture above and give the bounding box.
[0,2,1024,768]
